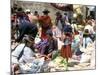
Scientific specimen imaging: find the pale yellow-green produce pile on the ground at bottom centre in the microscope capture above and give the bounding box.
[48,56,67,72]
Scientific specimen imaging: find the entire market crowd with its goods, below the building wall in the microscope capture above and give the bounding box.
[11,4,96,75]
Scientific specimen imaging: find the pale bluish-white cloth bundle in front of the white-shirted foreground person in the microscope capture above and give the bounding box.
[20,58,44,73]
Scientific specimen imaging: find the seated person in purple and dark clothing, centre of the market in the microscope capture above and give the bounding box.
[36,30,58,59]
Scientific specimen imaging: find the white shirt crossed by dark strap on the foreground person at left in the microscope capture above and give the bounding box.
[12,44,35,63]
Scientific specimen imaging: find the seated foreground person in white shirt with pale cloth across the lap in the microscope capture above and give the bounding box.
[11,36,44,75]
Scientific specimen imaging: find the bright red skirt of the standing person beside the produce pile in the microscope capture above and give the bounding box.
[61,44,72,59]
